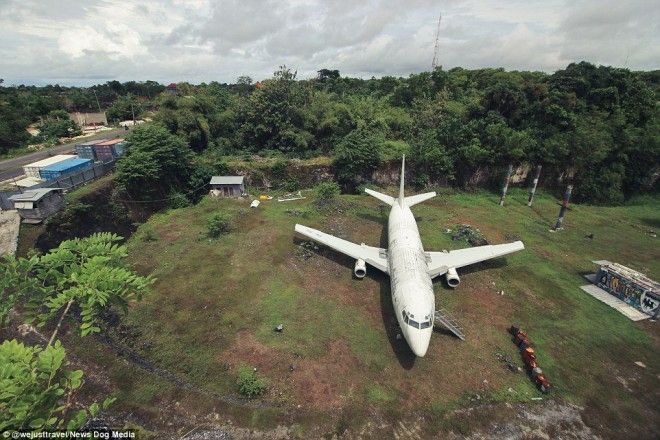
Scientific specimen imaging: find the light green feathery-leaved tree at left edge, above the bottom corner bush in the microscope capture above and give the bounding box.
[5,232,154,345]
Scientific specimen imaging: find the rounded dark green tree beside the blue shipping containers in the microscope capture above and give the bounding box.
[115,124,193,201]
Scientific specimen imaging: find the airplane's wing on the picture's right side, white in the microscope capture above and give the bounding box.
[426,241,525,278]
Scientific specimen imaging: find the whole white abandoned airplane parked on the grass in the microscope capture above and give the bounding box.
[295,156,525,357]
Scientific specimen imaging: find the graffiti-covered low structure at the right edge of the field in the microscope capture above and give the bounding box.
[596,267,660,317]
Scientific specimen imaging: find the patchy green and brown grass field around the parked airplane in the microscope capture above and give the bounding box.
[63,189,660,438]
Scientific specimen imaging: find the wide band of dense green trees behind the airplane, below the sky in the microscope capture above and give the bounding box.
[0,62,660,205]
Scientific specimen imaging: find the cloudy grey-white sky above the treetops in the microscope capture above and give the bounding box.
[0,0,660,85]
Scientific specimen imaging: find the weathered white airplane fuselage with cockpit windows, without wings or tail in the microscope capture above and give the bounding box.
[387,203,435,357]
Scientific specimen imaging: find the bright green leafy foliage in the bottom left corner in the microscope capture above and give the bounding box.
[0,340,114,432]
